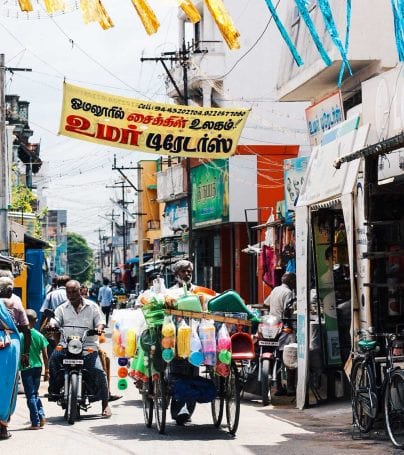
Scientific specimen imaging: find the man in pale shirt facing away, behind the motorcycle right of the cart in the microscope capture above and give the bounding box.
[264,272,296,396]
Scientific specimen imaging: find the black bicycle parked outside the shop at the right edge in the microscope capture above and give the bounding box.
[351,328,404,449]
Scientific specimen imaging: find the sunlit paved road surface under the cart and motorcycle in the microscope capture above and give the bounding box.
[0,332,402,455]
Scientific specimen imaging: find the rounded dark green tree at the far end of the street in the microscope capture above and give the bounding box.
[67,232,94,283]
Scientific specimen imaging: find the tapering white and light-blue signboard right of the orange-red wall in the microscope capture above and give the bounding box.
[283,156,309,224]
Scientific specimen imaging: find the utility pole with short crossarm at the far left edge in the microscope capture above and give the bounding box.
[0,54,32,256]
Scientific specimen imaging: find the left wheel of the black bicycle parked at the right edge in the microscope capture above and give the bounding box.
[351,360,377,433]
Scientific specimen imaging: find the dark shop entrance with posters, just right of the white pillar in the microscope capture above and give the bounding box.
[309,207,351,401]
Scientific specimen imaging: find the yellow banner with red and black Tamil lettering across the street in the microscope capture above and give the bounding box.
[59,83,250,159]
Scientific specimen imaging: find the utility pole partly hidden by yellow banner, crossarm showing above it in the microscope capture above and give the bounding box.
[139,40,193,268]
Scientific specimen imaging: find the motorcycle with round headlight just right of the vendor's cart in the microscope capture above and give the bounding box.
[241,315,293,406]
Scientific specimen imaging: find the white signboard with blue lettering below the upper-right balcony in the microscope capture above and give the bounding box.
[306,90,344,145]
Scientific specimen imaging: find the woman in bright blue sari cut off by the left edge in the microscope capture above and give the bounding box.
[0,289,20,440]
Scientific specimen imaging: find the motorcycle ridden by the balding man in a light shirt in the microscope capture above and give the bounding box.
[43,312,99,425]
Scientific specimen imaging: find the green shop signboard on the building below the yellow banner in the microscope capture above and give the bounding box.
[191,160,229,227]
